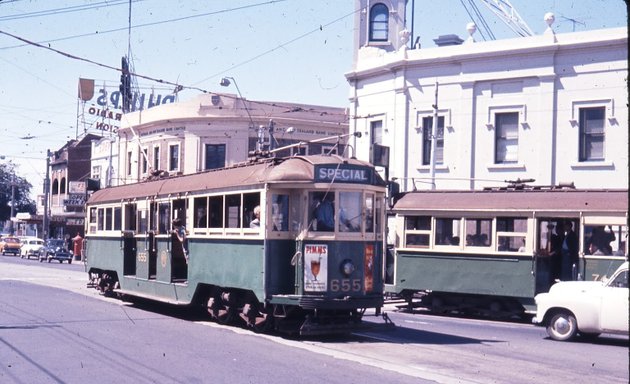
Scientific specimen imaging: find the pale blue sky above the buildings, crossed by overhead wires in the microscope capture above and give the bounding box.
[0,0,627,199]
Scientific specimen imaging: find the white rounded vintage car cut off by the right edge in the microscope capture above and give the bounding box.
[533,261,630,341]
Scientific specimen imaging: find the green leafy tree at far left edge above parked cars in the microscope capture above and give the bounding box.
[0,162,37,221]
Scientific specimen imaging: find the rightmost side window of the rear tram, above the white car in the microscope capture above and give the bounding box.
[582,225,627,256]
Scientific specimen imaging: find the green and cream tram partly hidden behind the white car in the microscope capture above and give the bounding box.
[385,187,628,317]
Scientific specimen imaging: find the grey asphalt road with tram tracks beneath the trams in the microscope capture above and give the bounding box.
[0,257,629,384]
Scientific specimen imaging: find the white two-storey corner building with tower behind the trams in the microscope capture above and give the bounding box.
[346,0,628,190]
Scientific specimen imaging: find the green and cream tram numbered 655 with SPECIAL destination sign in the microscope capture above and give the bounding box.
[86,155,385,335]
